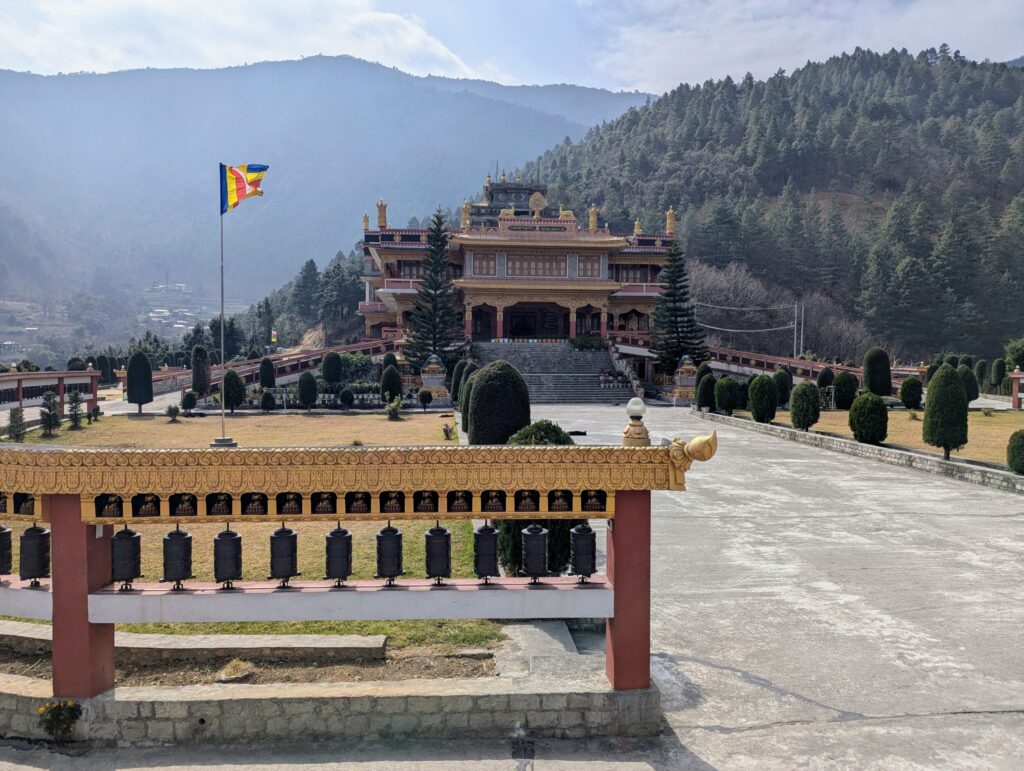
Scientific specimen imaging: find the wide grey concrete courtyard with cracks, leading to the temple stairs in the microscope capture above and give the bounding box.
[0,405,1024,769]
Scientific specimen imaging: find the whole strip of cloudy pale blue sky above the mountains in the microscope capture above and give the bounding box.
[0,0,1024,94]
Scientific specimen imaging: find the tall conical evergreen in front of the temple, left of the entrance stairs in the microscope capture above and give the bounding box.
[404,209,465,369]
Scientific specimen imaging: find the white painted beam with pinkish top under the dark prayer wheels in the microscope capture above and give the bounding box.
[89,579,613,624]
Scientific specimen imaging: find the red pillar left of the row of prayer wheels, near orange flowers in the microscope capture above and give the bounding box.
[49,496,114,698]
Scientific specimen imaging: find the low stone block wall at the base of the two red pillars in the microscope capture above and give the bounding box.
[0,668,662,746]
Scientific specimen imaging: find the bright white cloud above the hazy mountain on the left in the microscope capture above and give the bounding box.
[0,0,479,77]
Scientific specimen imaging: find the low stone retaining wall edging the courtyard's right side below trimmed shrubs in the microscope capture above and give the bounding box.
[691,410,1024,492]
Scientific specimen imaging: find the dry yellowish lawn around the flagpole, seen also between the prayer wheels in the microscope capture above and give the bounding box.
[6,412,504,650]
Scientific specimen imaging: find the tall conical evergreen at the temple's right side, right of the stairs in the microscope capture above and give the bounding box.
[651,241,708,372]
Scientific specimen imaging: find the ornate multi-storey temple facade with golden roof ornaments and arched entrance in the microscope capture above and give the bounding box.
[359,173,675,341]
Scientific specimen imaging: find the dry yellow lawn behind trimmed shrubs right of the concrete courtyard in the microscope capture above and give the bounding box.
[736,410,1024,466]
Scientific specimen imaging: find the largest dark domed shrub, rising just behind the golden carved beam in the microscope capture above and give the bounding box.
[463,358,529,444]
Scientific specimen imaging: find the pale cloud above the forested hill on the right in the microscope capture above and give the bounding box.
[580,0,1024,93]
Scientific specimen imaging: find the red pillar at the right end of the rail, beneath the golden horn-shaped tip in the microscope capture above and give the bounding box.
[604,490,650,691]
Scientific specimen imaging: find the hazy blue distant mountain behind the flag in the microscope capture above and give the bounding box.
[0,56,647,297]
